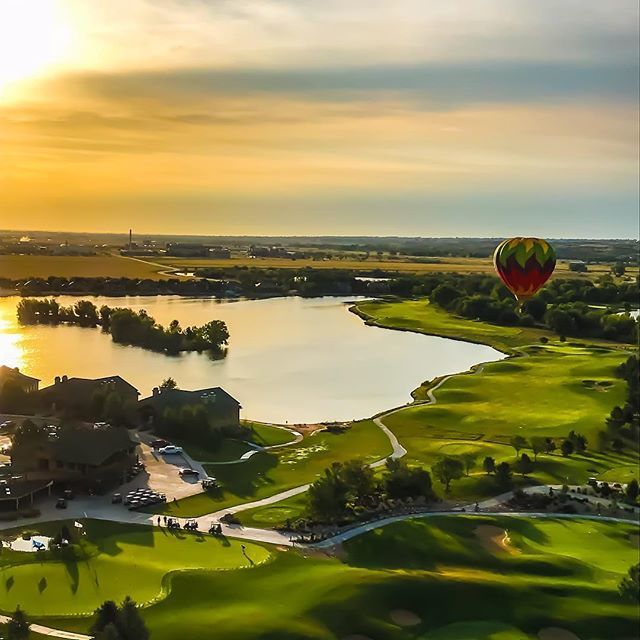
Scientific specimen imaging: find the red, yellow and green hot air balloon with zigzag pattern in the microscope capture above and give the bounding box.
[493,238,556,303]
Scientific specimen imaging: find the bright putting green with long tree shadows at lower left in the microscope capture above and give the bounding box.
[0,521,270,616]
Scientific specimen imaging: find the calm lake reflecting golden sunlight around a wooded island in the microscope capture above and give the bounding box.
[0,296,504,424]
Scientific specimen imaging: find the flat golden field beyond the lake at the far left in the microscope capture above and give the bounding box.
[0,255,167,280]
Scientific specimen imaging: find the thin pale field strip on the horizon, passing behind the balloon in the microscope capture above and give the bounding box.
[154,256,638,277]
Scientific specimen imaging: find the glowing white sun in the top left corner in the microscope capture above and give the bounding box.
[0,0,70,97]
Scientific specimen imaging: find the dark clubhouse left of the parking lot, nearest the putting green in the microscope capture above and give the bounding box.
[11,425,138,487]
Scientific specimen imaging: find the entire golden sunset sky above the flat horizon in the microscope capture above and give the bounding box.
[0,0,639,238]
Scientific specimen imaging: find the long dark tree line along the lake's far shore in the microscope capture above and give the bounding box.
[0,266,638,310]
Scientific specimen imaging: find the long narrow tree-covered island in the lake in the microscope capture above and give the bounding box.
[17,298,229,358]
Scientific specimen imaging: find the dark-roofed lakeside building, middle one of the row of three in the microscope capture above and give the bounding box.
[38,376,140,413]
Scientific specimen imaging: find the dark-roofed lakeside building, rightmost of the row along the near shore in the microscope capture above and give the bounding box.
[138,387,241,427]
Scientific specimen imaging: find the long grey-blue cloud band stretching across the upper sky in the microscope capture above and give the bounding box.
[46,61,639,110]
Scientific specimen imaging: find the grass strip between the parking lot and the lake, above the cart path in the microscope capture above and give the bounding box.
[154,420,391,517]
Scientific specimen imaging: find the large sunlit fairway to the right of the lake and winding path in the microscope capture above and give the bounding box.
[356,300,637,500]
